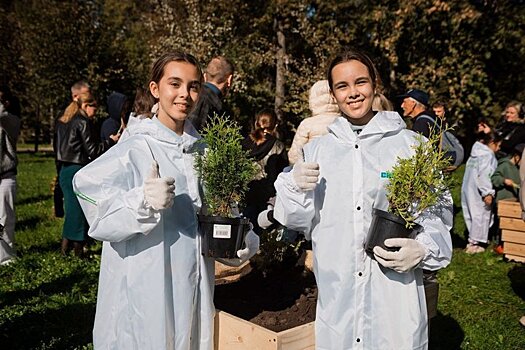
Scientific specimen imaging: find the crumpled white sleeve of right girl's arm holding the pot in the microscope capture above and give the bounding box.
[416,191,454,270]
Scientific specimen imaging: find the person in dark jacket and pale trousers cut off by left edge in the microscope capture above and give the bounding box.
[0,86,20,265]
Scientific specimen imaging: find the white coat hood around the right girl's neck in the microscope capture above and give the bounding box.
[328,111,406,142]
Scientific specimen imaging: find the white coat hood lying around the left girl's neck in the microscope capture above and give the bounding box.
[126,116,202,152]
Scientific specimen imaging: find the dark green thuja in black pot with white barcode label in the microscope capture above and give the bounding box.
[195,114,256,258]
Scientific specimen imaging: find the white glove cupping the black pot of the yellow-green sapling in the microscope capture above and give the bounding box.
[374,238,426,272]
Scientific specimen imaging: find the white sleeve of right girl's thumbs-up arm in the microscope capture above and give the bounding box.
[273,172,315,237]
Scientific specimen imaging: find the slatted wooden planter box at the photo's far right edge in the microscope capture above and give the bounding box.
[498,200,525,262]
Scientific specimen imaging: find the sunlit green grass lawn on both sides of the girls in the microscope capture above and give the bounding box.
[0,153,525,350]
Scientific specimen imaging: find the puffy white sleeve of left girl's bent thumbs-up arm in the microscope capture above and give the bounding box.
[73,146,161,242]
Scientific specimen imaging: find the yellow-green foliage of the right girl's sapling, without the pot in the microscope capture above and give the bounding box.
[386,124,452,228]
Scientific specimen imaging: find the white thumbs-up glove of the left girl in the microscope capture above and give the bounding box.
[144,161,175,210]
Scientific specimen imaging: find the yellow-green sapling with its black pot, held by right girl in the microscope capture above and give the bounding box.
[365,129,451,257]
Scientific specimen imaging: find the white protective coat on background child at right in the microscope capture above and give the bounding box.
[461,141,498,243]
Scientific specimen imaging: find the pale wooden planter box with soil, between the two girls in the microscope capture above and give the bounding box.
[214,310,315,350]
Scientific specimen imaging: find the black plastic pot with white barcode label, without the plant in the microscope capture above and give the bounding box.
[197,215,250,259]
